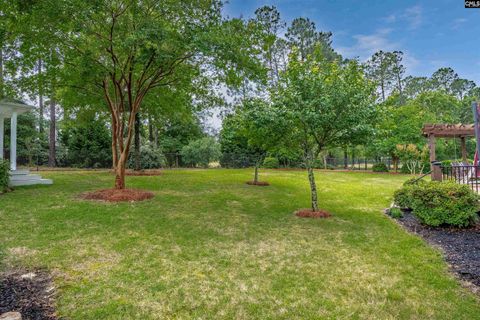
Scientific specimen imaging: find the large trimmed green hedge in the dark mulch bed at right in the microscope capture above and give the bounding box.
[394,181,479,227]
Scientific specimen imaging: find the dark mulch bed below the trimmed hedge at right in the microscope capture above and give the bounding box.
[390,211,480,292]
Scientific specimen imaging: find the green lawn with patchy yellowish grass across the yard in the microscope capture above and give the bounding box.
[0,169,480,319]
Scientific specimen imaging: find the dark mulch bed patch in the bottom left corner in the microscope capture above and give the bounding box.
[0,271,58,320]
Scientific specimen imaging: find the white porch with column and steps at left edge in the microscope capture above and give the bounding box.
[0,99,52,187]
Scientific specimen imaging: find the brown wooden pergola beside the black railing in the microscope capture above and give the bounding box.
[422,124,475,181]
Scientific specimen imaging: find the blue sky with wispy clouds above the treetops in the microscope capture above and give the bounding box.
[224,0,480,85]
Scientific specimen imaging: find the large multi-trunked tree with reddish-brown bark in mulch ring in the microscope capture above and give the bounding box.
[21,0,261,189]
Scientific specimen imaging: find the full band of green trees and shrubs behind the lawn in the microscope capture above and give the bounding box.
[0,0,480,209]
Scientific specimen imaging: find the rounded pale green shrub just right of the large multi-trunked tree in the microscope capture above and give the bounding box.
[181,137,221,168]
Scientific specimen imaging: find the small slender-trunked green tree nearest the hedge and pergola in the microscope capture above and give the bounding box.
[271,48,375,211]
